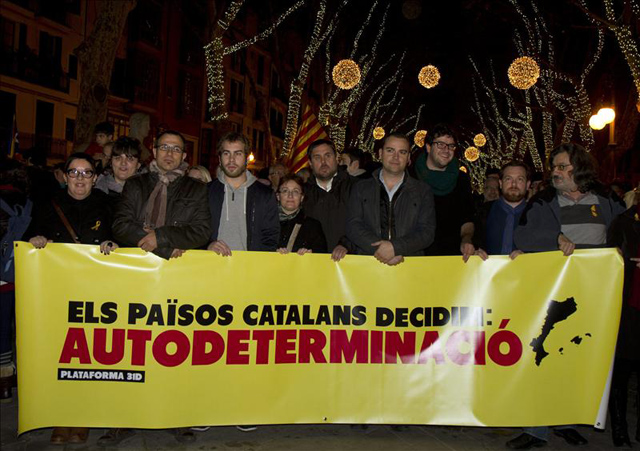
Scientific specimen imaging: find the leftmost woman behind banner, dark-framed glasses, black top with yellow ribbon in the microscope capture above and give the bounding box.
[27,152,118,444]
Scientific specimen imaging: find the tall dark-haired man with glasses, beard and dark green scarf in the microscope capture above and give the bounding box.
[414,124,476,262]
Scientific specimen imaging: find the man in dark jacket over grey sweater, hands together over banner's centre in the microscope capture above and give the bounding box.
[347,133,436,265]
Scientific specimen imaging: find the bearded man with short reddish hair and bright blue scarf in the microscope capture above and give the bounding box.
[475,160,531,259]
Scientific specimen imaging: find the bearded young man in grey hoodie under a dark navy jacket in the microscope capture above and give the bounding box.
[208,132,280,256]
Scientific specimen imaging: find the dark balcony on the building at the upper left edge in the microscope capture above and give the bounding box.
[0,48,69,94]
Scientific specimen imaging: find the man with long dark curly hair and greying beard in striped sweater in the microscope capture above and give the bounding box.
[507,143,624,449]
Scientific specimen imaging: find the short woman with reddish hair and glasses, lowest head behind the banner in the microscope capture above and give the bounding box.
[276,175,327,255]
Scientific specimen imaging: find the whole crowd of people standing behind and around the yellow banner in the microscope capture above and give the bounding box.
[0,124,640,449]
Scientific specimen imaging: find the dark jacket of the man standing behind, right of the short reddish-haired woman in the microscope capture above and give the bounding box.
[302,168,361,252]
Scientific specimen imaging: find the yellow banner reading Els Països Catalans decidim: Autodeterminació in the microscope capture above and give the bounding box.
[15,243,623,432]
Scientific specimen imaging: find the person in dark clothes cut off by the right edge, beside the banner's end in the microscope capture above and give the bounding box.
[608,191,640,447]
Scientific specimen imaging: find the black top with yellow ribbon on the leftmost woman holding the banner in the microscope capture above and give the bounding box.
[25,189,113,244]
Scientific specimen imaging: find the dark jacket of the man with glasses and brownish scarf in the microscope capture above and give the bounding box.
[113,172,211,259]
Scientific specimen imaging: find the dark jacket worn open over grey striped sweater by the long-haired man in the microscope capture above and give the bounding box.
[514,187,624,252]
